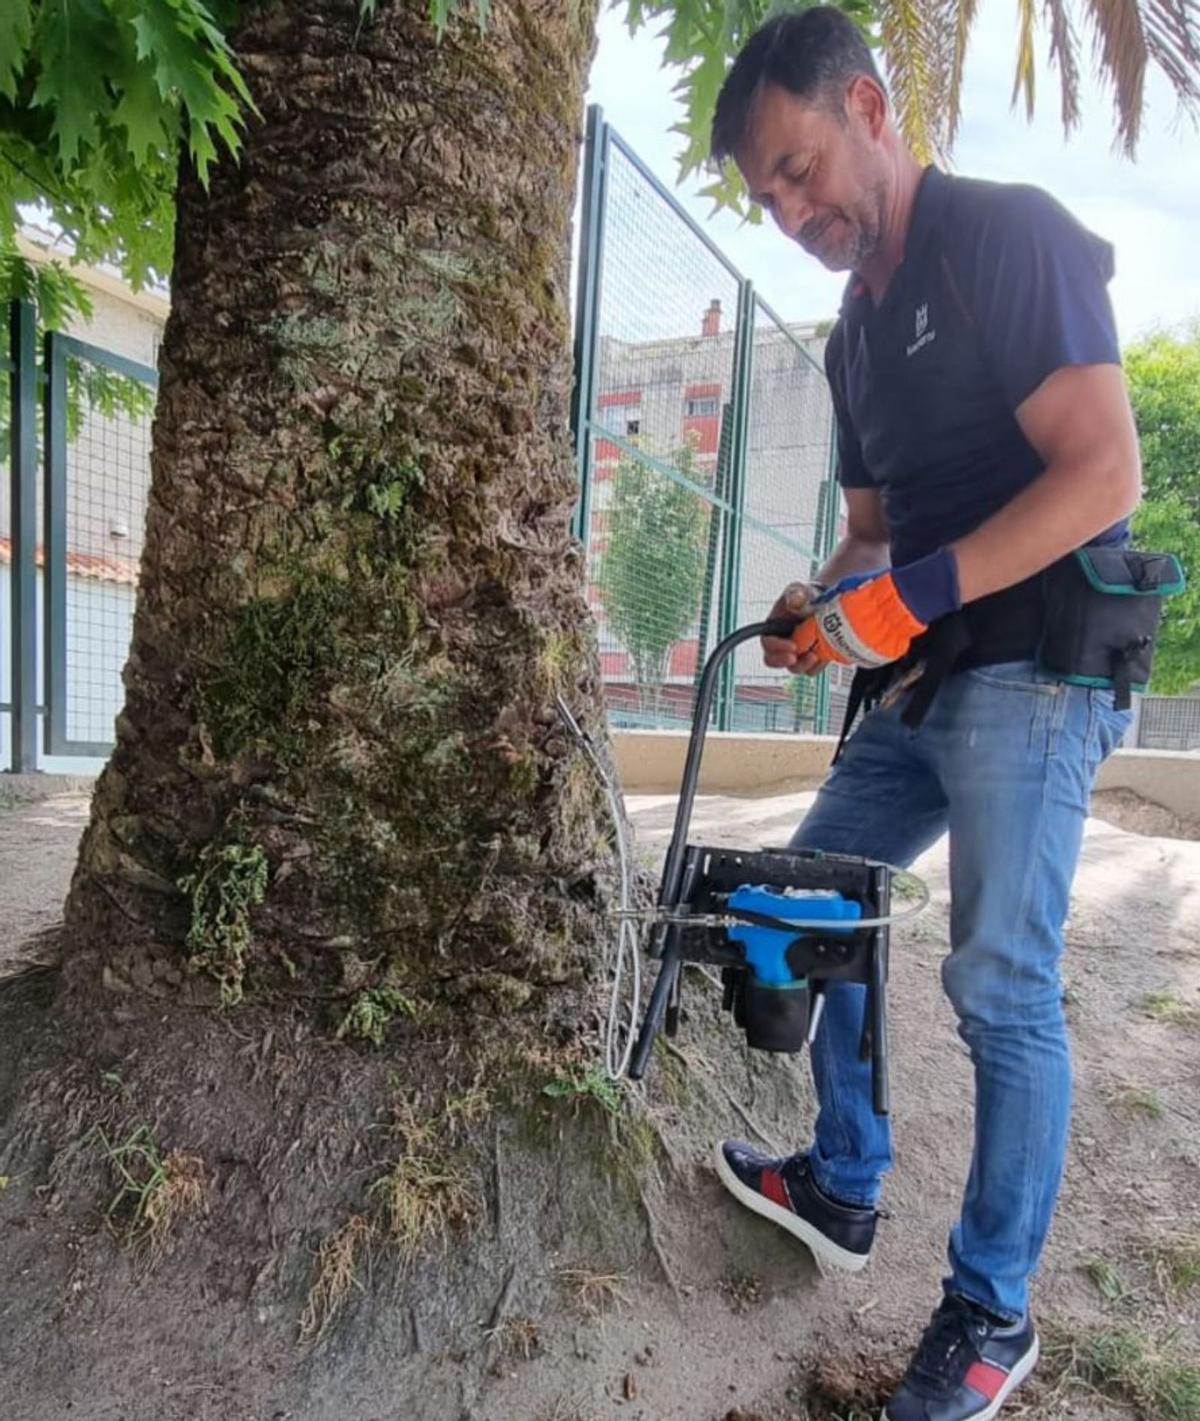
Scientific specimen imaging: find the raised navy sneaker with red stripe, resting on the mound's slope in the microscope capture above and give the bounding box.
[715,1140,879,1273]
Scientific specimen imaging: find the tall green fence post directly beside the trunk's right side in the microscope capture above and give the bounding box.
[570,104,609,553]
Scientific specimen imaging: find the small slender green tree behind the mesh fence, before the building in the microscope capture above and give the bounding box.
[599,445,711,713]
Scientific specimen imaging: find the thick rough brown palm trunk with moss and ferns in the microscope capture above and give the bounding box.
[67,0,609,1009]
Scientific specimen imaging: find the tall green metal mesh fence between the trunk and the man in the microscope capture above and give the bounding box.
[573,108,837,732]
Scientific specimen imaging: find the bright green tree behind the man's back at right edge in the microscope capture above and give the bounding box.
[1125,323,1200,695]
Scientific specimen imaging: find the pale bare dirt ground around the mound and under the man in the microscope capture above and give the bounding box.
[0,793,1200,1421]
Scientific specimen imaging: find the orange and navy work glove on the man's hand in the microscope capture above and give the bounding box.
[792,547,963,666]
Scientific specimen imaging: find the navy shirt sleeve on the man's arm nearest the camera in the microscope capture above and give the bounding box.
[968,188,1120,409]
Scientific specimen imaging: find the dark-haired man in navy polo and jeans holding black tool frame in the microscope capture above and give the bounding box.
[712,9,1140,1421]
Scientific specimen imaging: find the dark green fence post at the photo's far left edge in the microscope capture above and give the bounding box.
[9,301,37,774]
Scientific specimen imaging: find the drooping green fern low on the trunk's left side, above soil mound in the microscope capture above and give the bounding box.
[179,843,269,1006]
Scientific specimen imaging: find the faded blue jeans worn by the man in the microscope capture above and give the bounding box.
[792,662,1129,1319]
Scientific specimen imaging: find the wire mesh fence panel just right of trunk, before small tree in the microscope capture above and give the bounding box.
[586,126,739,725]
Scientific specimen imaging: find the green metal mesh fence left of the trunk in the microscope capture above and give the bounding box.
[0,301,158,772]
